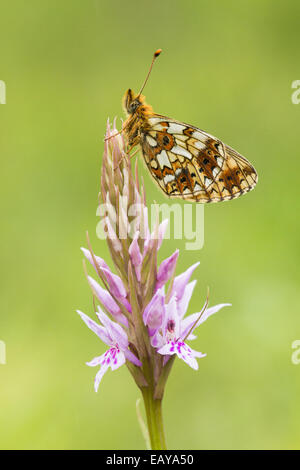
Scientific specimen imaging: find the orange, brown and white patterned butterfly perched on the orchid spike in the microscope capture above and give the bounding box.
[122,49,257,203]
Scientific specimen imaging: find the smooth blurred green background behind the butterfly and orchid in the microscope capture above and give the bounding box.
[0,0,300,449]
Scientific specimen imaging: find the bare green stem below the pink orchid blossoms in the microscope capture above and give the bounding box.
[141,387,167,450]
